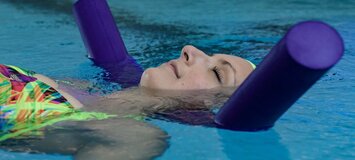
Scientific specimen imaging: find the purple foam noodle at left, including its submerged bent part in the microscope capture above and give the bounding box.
[73,0,143,87]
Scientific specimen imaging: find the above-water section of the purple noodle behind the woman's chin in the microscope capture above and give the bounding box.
[74,0,128,64]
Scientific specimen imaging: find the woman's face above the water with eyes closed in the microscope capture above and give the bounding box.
[140,45,253,90]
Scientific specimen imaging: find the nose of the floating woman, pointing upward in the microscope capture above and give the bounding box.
[180,45,208,66]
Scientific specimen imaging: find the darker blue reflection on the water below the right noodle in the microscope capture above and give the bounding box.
[217,129,291,160]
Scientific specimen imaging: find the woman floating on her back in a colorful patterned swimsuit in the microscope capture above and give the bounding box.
[0,46,255,159]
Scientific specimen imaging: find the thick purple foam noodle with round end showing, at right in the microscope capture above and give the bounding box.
[215,21,344,131]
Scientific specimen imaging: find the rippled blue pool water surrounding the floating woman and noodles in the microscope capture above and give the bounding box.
[0,0,355,160]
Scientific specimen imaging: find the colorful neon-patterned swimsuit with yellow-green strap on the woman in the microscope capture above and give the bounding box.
[0,64,111,141]
